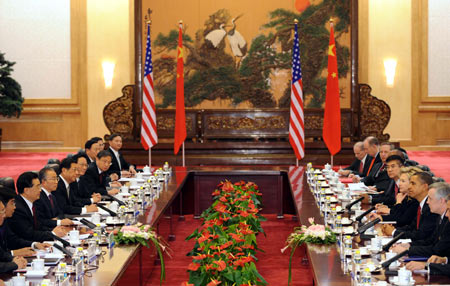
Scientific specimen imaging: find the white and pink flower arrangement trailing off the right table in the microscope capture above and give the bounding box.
[281,218,336,285]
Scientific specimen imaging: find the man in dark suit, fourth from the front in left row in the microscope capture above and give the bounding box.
[54,158,98,215]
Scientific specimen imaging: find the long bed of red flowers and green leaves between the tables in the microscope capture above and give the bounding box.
[182,181,267,286]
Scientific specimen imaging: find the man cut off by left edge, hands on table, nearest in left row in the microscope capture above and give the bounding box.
[0,187,51,256]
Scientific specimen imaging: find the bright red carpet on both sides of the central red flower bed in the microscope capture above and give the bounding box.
[146,215,312,286]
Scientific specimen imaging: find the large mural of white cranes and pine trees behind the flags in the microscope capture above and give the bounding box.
[142,0,351,109]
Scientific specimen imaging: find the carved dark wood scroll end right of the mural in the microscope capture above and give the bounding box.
[359,84,391,141]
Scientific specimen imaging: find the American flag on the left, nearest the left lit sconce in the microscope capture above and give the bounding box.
[141,24,158,150]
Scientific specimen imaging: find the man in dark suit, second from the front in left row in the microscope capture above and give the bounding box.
[9,172,67,242]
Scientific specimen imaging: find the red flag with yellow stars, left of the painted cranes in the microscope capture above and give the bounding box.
[173,23,186,155]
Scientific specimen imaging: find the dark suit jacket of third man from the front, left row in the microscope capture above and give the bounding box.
[34,190,64,230]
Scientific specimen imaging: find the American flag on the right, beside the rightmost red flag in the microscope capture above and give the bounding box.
[289,23,305,160]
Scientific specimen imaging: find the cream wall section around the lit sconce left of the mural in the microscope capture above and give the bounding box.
[87,0,134,137]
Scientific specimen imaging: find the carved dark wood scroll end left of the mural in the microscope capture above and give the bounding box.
[103,85,134,140]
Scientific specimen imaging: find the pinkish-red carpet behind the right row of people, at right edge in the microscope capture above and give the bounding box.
[408,151,450,182]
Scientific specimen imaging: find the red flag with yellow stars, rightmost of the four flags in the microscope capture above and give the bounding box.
[322,24,341,155]
